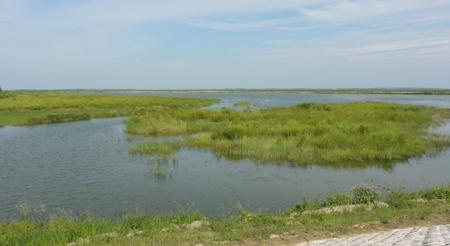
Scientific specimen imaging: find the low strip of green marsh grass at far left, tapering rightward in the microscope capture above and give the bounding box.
[0,92,217,126]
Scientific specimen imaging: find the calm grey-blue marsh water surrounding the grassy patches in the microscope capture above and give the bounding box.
[0,93,450,220]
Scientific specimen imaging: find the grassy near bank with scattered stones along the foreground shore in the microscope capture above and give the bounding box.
[0,187,450,246]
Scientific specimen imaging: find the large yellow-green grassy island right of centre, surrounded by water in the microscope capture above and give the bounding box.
[127,102,450,164]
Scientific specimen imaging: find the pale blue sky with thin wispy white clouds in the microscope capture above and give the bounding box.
[0,0,450,90]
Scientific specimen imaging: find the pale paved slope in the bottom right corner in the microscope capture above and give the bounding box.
[297,225,450,246]
